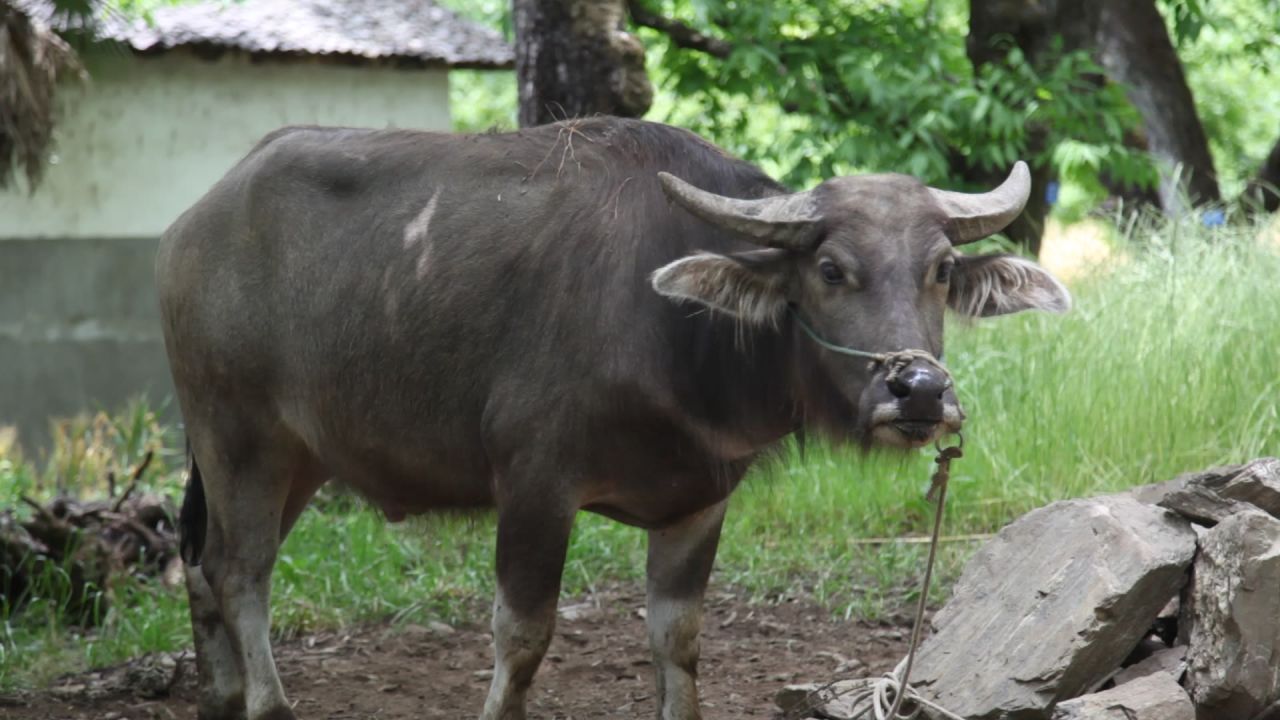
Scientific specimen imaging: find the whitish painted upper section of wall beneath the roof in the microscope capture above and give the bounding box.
[0,50,449,240]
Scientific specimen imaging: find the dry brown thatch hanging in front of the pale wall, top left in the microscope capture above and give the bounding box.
[0,0,84,188]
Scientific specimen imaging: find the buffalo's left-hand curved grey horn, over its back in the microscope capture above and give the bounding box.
[658,173,822,250]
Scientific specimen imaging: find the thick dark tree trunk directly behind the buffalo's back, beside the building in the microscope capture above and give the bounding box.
[513,0,653,127]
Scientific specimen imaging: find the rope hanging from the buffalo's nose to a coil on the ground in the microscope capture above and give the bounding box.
[801,436,965,720]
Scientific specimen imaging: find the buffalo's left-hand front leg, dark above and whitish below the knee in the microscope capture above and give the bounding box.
[481,493,573,720]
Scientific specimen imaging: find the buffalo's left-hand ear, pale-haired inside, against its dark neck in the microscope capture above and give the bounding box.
[650,250,791,325]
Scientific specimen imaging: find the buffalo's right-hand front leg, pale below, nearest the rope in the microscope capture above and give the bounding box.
[646,502,724,720]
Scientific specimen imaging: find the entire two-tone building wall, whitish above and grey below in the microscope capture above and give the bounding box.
[0,50,449,447]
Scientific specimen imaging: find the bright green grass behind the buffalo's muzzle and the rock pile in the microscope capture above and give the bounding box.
[721,211,1280,612]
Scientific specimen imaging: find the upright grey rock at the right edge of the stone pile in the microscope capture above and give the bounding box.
[1184,510,1280,719]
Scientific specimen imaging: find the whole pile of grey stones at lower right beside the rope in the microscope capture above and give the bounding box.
[778,459,1280,720]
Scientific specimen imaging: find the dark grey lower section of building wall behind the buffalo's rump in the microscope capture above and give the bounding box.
[0,238,177,450]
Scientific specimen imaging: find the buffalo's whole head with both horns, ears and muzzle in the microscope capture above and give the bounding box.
[653,163,1071,447]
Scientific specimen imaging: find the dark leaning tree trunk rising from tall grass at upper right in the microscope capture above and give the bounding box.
[1089,0,1222,214]
